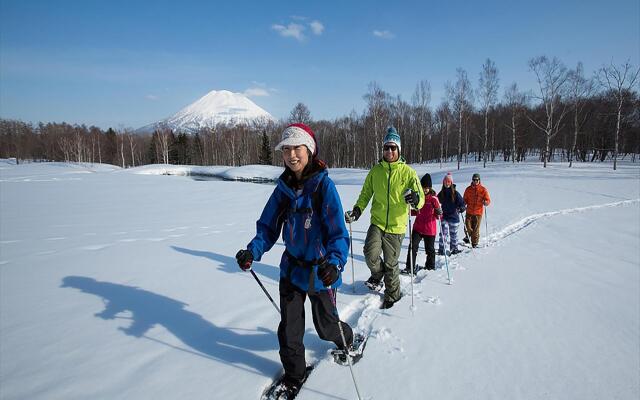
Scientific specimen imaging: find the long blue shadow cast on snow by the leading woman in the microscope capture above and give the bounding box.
[60,276,280,376]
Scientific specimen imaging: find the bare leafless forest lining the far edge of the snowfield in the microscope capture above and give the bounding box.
[0,57,640,169]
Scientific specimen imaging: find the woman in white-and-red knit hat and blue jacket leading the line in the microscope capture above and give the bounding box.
[236,124,353,396]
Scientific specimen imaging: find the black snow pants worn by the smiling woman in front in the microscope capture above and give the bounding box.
[278,278,353,383]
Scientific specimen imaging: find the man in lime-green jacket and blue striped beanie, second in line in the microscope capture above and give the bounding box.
[345,127,424,308]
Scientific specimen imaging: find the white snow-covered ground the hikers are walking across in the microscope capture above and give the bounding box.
[0,160,640,400]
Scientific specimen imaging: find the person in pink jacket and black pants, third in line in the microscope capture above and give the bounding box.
[402,174,442,274]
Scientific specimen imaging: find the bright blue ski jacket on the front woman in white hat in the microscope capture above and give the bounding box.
[247,165,349,292]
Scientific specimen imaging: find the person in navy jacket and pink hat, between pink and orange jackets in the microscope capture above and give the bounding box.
[438,173,465,255]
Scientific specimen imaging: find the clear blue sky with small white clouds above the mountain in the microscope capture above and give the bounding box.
[0,0,640,128]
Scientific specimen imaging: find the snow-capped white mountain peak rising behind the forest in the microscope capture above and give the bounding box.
[137,90,275,133]
